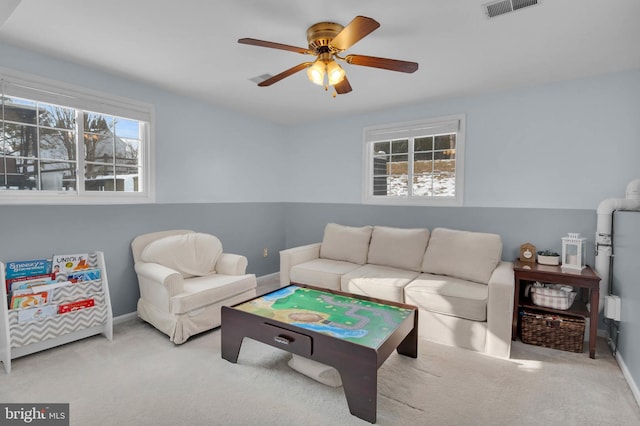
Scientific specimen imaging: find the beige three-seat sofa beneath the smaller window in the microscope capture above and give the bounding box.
[280,223,514,358]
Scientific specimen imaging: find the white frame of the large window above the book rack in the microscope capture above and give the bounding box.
[0,67,156,205]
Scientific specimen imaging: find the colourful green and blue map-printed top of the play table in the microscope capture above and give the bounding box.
[234,285,414,348]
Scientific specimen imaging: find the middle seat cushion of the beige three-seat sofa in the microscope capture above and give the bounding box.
[340,265,419,302]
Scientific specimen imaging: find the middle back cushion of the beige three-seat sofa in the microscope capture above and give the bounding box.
[367,226,429,271]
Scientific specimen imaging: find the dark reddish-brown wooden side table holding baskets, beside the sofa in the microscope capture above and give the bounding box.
[511,260,600,358]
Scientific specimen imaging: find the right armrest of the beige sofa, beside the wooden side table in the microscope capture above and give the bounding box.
[486,262,515,358]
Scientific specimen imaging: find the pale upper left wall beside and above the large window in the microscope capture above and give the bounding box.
[0,43,284,203]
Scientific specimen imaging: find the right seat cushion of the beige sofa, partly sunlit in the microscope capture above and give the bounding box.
[404,274,489,322]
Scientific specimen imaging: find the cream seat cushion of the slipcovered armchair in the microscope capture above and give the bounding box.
[169,274,256,314]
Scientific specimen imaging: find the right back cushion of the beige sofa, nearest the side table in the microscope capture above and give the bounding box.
[422,228,502,284]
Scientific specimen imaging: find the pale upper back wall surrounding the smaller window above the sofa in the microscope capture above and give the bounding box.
[286,70,640,209]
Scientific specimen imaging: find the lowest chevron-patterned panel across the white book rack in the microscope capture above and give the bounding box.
[10,304,107,348]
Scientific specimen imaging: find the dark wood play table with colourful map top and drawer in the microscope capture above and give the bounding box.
[221,284,418,423]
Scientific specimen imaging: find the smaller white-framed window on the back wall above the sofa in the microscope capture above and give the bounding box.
[363,115,465,206]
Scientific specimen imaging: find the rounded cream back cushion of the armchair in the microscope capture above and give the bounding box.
[140,232,222,278]
